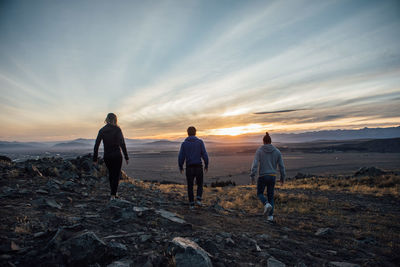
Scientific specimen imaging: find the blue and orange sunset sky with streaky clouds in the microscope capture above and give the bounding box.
[0,0,400,141]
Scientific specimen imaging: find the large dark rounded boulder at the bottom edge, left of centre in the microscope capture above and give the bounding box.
[59,232,108,265]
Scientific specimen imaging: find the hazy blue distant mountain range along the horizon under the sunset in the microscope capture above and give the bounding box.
[0,126,400,152]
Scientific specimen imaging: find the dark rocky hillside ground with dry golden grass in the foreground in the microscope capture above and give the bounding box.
[0,156,400,266]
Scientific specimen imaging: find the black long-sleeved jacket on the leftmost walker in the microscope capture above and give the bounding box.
[93,124,129,161]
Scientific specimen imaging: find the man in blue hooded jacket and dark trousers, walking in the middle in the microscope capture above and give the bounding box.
[178,126,208,209]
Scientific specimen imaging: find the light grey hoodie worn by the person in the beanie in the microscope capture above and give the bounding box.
[250,144,286,181]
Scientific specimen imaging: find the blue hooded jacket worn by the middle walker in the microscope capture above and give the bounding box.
[178,136,208,170]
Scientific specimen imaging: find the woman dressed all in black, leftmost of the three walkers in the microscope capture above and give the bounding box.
[93,113,129,200]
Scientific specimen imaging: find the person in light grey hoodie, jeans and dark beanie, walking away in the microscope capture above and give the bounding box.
[250,132,286,222]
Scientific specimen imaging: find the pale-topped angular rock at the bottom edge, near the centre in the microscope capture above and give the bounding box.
[168,237,212,267]
